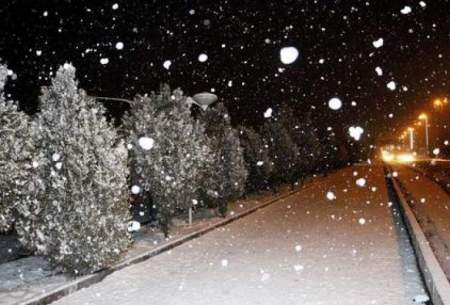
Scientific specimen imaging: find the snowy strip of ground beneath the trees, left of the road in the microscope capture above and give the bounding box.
[0,187,291,305]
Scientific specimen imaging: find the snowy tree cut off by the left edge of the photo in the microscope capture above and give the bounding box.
[0,65,34,232]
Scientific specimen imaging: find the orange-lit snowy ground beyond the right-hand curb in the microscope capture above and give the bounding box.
[394,166,450,279]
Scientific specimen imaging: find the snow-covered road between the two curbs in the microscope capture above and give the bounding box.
[52,166,424,305]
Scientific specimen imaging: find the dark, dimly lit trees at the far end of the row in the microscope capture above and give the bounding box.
[240,105,354,192]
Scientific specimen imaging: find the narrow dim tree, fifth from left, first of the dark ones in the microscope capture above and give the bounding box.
[239,127,273,192]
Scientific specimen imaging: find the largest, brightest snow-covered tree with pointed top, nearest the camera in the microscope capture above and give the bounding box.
[17,64,130,274]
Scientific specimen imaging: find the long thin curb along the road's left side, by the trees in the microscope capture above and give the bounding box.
[15,188,303,305]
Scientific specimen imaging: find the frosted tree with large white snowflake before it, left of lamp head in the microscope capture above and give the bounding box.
[124,86,213,235]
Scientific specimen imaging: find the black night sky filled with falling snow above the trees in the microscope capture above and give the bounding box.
[0,0,450,140]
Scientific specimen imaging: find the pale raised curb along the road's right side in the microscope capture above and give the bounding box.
[391,173,450,305]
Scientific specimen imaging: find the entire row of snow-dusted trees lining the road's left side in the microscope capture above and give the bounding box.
[0,64,358,274]
